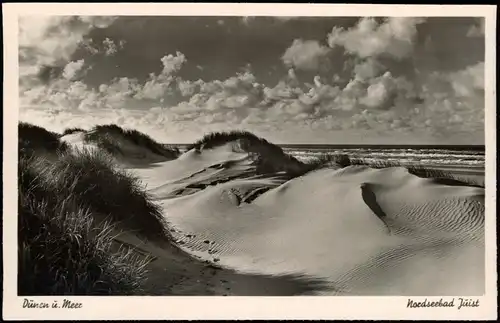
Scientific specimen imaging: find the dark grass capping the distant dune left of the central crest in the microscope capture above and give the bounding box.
[84,124,179,159]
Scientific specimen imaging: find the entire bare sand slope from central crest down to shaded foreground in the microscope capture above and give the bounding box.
[61,137,484,296]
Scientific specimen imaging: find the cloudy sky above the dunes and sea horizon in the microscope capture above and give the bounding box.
[19,16,485,144]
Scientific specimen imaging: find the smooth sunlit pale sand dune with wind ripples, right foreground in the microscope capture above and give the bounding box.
[136,150,484,295]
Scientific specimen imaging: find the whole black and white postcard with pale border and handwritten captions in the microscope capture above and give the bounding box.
[4,4,496,317]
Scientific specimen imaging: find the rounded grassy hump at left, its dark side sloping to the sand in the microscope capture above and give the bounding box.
[43,150,172,241]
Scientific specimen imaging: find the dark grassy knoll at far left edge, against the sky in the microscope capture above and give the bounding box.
[18,122,68,155]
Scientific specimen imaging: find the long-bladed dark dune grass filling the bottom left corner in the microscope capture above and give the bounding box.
[18,156,152,295]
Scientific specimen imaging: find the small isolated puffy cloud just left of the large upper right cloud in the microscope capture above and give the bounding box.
[282,39,329,71]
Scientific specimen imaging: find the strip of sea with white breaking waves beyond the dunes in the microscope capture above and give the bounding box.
[174,144,485,172]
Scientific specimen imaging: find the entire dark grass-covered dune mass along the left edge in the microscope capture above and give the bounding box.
[18,124,174,295]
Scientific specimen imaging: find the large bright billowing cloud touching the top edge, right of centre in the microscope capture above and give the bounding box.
[328,17,425,59]
